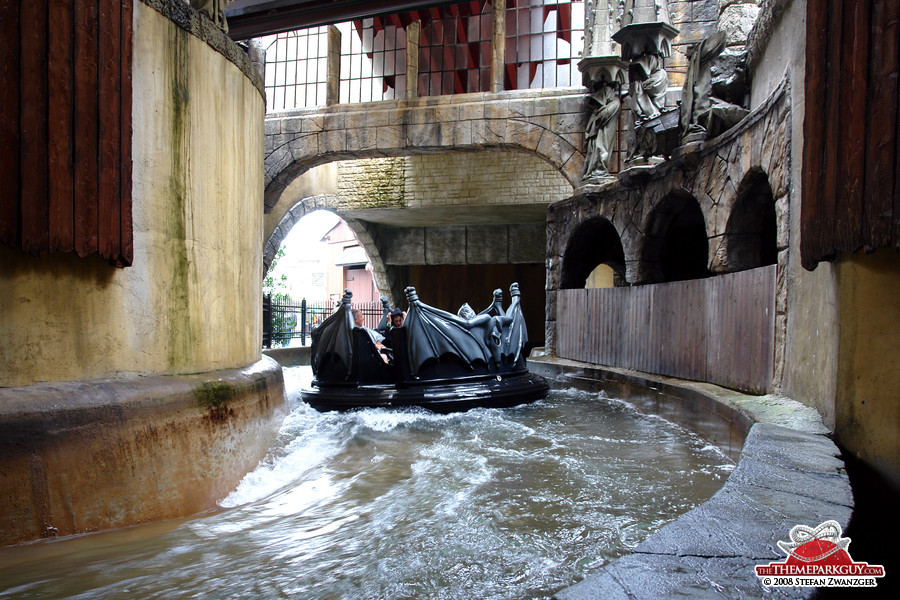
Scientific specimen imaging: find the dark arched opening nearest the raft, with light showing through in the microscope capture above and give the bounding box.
[559,217,626,289]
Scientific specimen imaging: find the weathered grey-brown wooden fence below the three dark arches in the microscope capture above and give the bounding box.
[556,265,775,392]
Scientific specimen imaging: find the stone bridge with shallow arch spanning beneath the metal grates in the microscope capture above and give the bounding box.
[265,88,588,213]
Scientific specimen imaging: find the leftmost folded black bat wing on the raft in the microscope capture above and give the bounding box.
[310,290,353,381]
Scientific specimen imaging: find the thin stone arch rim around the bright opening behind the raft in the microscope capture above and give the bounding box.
[263,194,397,302]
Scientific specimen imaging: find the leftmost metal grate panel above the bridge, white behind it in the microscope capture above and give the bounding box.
[263,27,328,112]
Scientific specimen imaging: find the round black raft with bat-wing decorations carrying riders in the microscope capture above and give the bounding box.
[300,283,550,412]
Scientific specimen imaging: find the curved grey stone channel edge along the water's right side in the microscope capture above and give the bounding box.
[529,357,853,600]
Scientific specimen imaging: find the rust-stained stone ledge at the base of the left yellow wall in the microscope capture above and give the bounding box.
[0,357,287,545]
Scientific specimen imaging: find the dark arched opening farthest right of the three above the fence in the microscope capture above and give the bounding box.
[724,167,778,272]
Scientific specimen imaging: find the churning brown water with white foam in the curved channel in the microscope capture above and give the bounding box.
[0,367,733,600]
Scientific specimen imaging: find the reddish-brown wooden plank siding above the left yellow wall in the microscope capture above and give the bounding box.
[0,0,134,266]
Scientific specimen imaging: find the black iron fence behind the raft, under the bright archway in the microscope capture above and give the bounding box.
[262,294,383,348]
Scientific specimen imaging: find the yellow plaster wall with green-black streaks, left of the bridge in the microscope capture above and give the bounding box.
[0,2,265,386]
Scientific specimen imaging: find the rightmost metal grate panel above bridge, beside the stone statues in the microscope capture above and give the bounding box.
[503,0,584,90]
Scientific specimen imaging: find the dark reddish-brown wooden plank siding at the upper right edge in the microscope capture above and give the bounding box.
[800,0,900,270]
